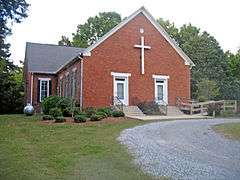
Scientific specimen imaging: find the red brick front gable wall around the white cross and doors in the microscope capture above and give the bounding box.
[83,15,190,107]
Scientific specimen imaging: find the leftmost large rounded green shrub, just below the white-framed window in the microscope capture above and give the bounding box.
[41,96,61,114]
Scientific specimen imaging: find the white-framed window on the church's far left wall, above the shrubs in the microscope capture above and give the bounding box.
[38,78,51,102]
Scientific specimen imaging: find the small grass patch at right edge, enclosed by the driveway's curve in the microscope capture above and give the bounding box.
[213,123,240,140]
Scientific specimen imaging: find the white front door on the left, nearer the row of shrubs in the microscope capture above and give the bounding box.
[114,77,128,105]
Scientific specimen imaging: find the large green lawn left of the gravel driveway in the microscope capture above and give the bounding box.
[0,115,156,180]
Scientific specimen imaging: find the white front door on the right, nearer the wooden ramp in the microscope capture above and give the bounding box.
[155,79,168,105]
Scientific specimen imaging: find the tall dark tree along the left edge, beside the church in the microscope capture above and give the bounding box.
[0,0,29,114]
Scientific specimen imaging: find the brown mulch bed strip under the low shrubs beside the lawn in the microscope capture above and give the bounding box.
[39,117,134,125]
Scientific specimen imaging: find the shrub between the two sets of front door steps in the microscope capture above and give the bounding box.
[137,101,163,115]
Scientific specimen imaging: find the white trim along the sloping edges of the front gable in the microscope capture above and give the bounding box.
[84,7,195,66]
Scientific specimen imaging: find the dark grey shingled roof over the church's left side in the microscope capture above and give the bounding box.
[25,42,85,73]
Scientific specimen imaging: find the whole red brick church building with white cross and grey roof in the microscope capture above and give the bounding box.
[24,7,194,111]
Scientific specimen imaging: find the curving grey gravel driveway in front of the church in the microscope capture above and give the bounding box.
[118,119,240,180]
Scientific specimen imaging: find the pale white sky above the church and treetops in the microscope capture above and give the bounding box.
[7,0,240,64]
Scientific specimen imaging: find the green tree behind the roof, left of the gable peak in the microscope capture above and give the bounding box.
[59,12,121,48]
